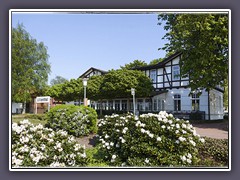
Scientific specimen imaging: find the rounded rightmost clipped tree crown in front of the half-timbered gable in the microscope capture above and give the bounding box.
[100,69,153,99]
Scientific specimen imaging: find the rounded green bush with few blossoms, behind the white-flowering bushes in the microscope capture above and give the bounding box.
[47,105,97,137]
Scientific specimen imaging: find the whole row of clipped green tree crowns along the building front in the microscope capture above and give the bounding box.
[45,69,153,101]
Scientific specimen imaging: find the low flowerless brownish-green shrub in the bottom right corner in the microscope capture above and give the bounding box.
[198,138,229,166]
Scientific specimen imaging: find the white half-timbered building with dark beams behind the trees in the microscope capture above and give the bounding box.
[80,53,224,120]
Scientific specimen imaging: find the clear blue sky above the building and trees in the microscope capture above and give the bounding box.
[12,13,169,82]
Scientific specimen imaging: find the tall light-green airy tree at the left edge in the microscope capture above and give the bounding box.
[11,24,51,113]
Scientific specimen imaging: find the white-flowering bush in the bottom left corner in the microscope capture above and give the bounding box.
[12,120,87,167]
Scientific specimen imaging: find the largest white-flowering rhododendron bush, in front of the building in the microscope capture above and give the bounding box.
[98,111,204,167]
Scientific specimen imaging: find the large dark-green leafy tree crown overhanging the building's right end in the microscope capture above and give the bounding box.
[159,14,229,90]
